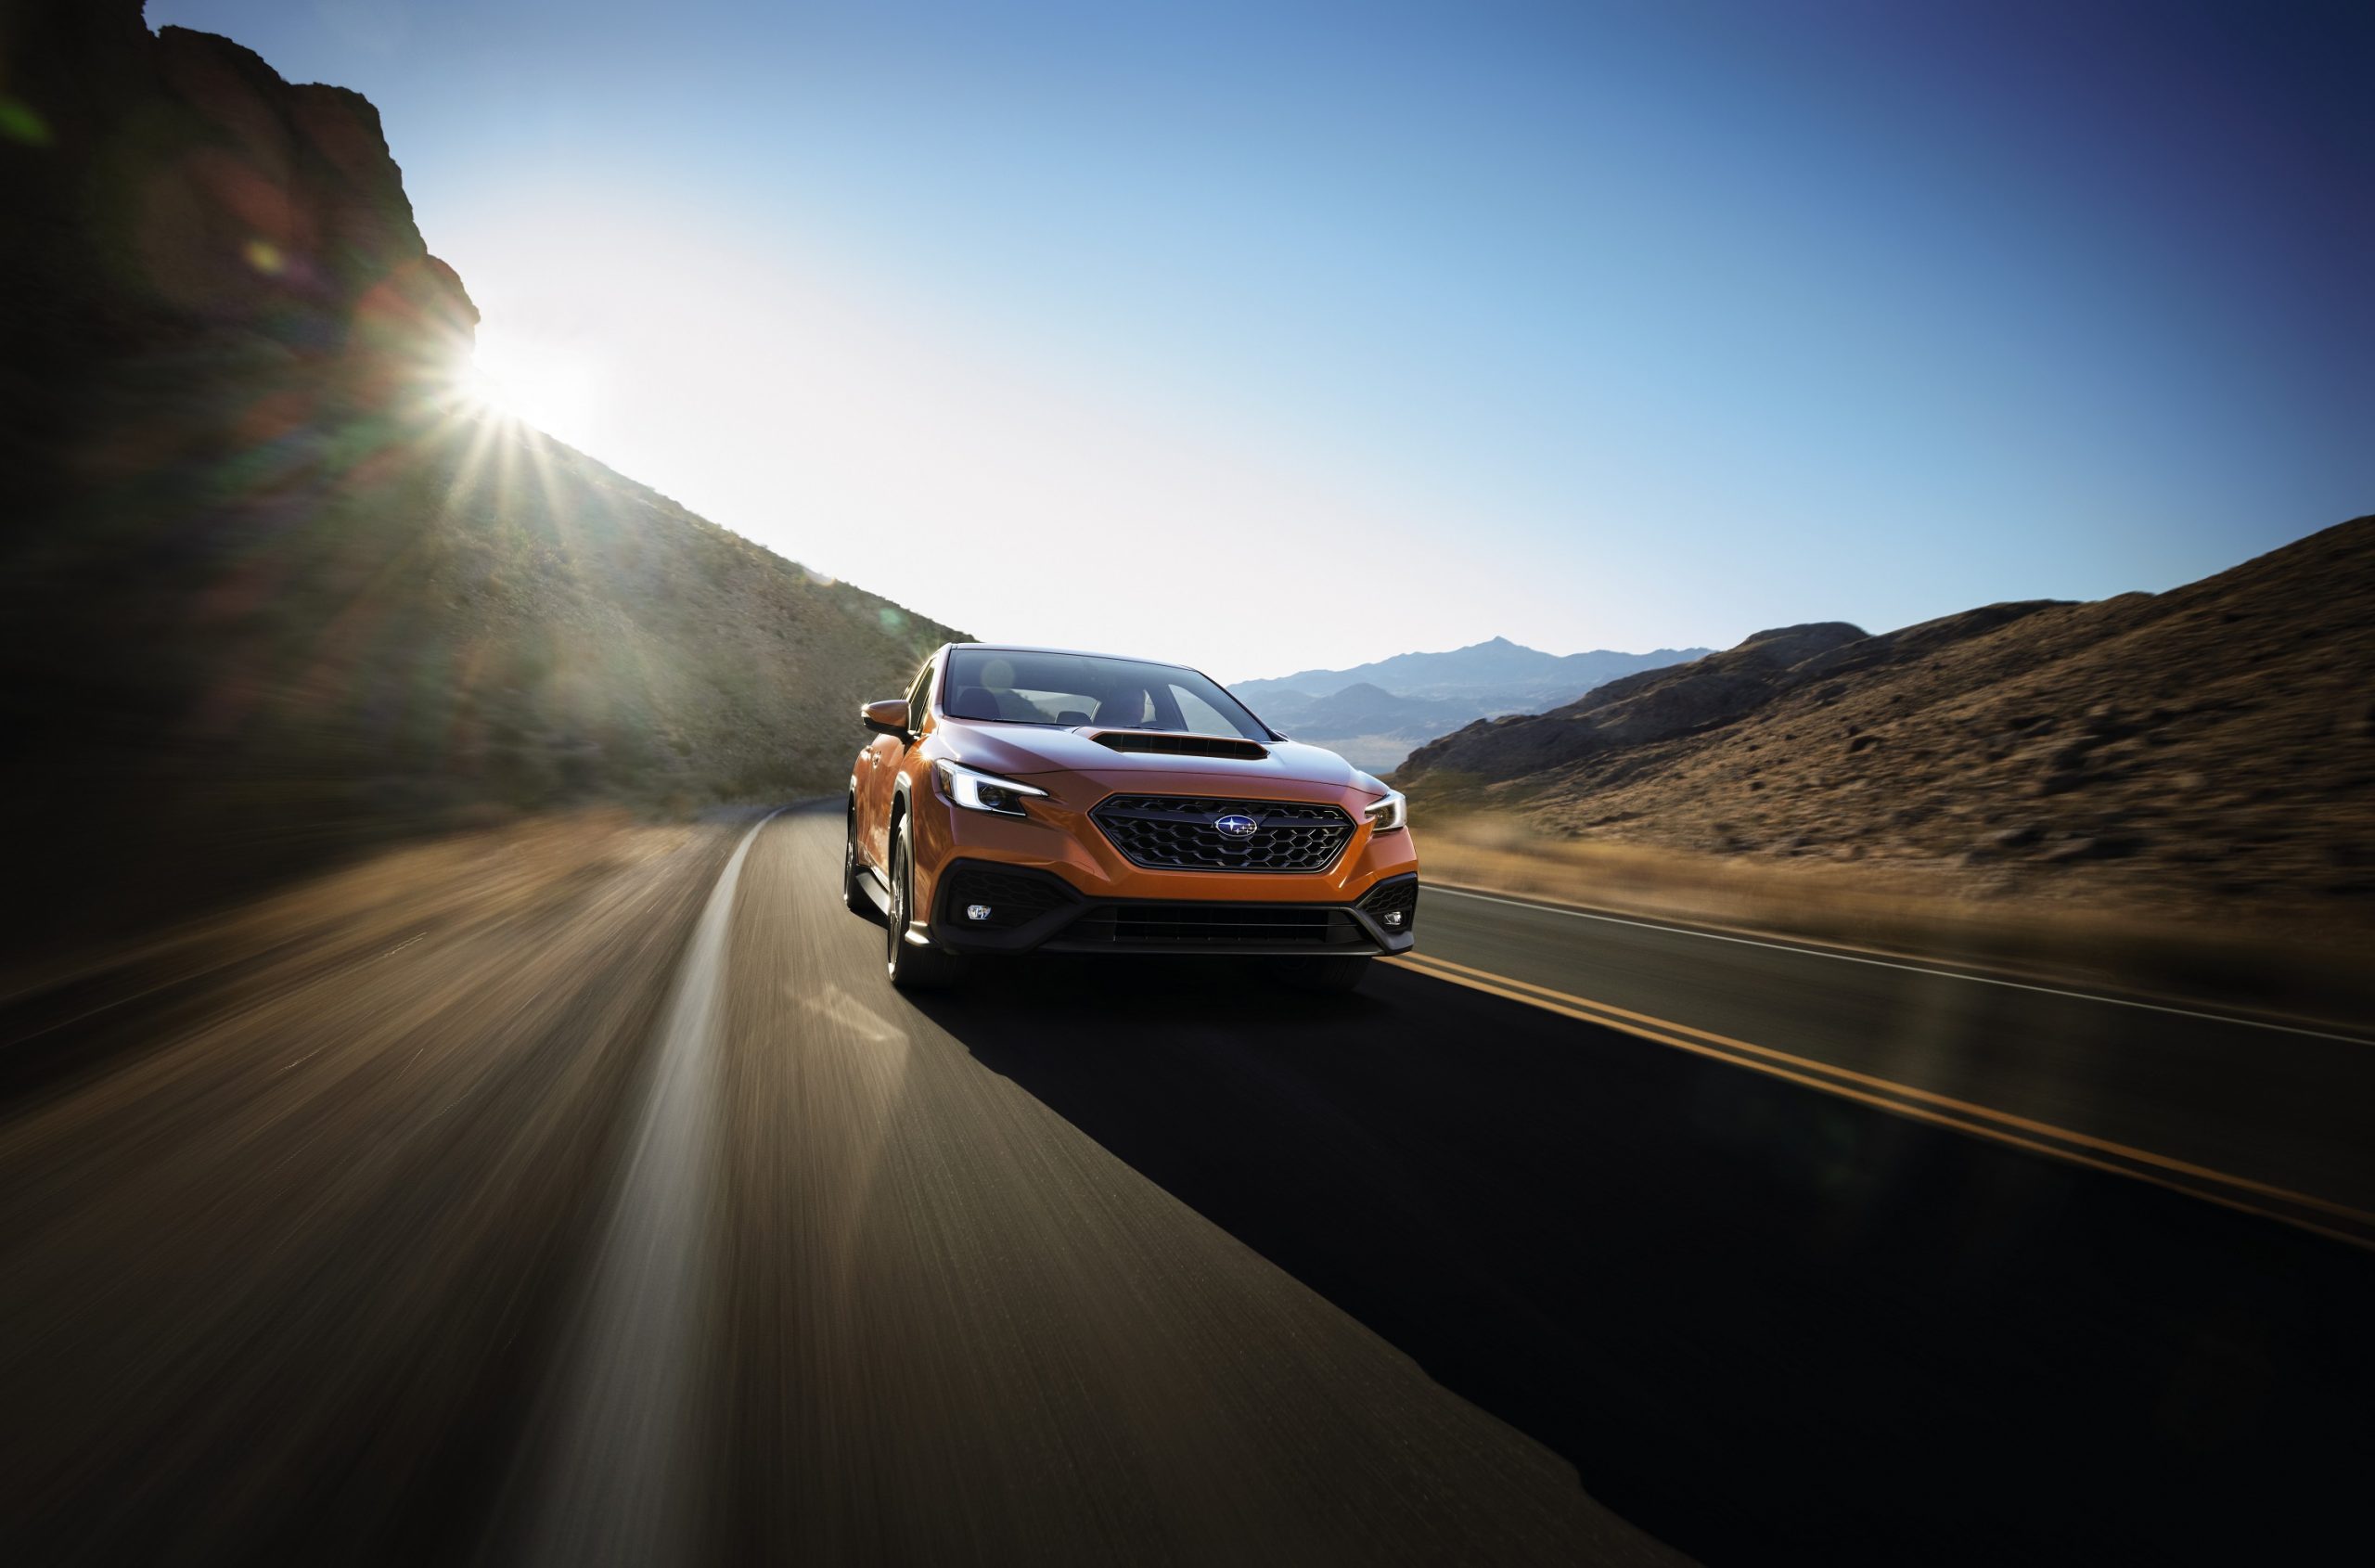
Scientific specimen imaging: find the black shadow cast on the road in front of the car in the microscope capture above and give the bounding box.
[924,958,2375,1563]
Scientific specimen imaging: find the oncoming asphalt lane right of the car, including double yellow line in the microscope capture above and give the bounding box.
[1413,889,2375,1245]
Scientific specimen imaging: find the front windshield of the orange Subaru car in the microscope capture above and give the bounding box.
[943,649,1273,741]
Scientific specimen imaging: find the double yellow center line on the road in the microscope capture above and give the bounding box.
[1387,953,2375,1250]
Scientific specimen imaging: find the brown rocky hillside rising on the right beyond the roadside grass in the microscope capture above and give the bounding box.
[1399,518,2375,922]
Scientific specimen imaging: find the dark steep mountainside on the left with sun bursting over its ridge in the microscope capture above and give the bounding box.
[0,0,953,935]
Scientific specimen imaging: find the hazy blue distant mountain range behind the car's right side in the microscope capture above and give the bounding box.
[1230,636,1708,772]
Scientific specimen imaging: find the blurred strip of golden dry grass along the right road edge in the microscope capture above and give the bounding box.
[1420,813,2375,1024]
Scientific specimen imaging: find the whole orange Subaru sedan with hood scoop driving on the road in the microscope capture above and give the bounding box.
[841,641,1418,991]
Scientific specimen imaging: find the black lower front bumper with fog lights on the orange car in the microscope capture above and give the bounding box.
[931,860,1418,958]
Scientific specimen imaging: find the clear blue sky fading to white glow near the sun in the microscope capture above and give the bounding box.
[148,0,2375,679]
